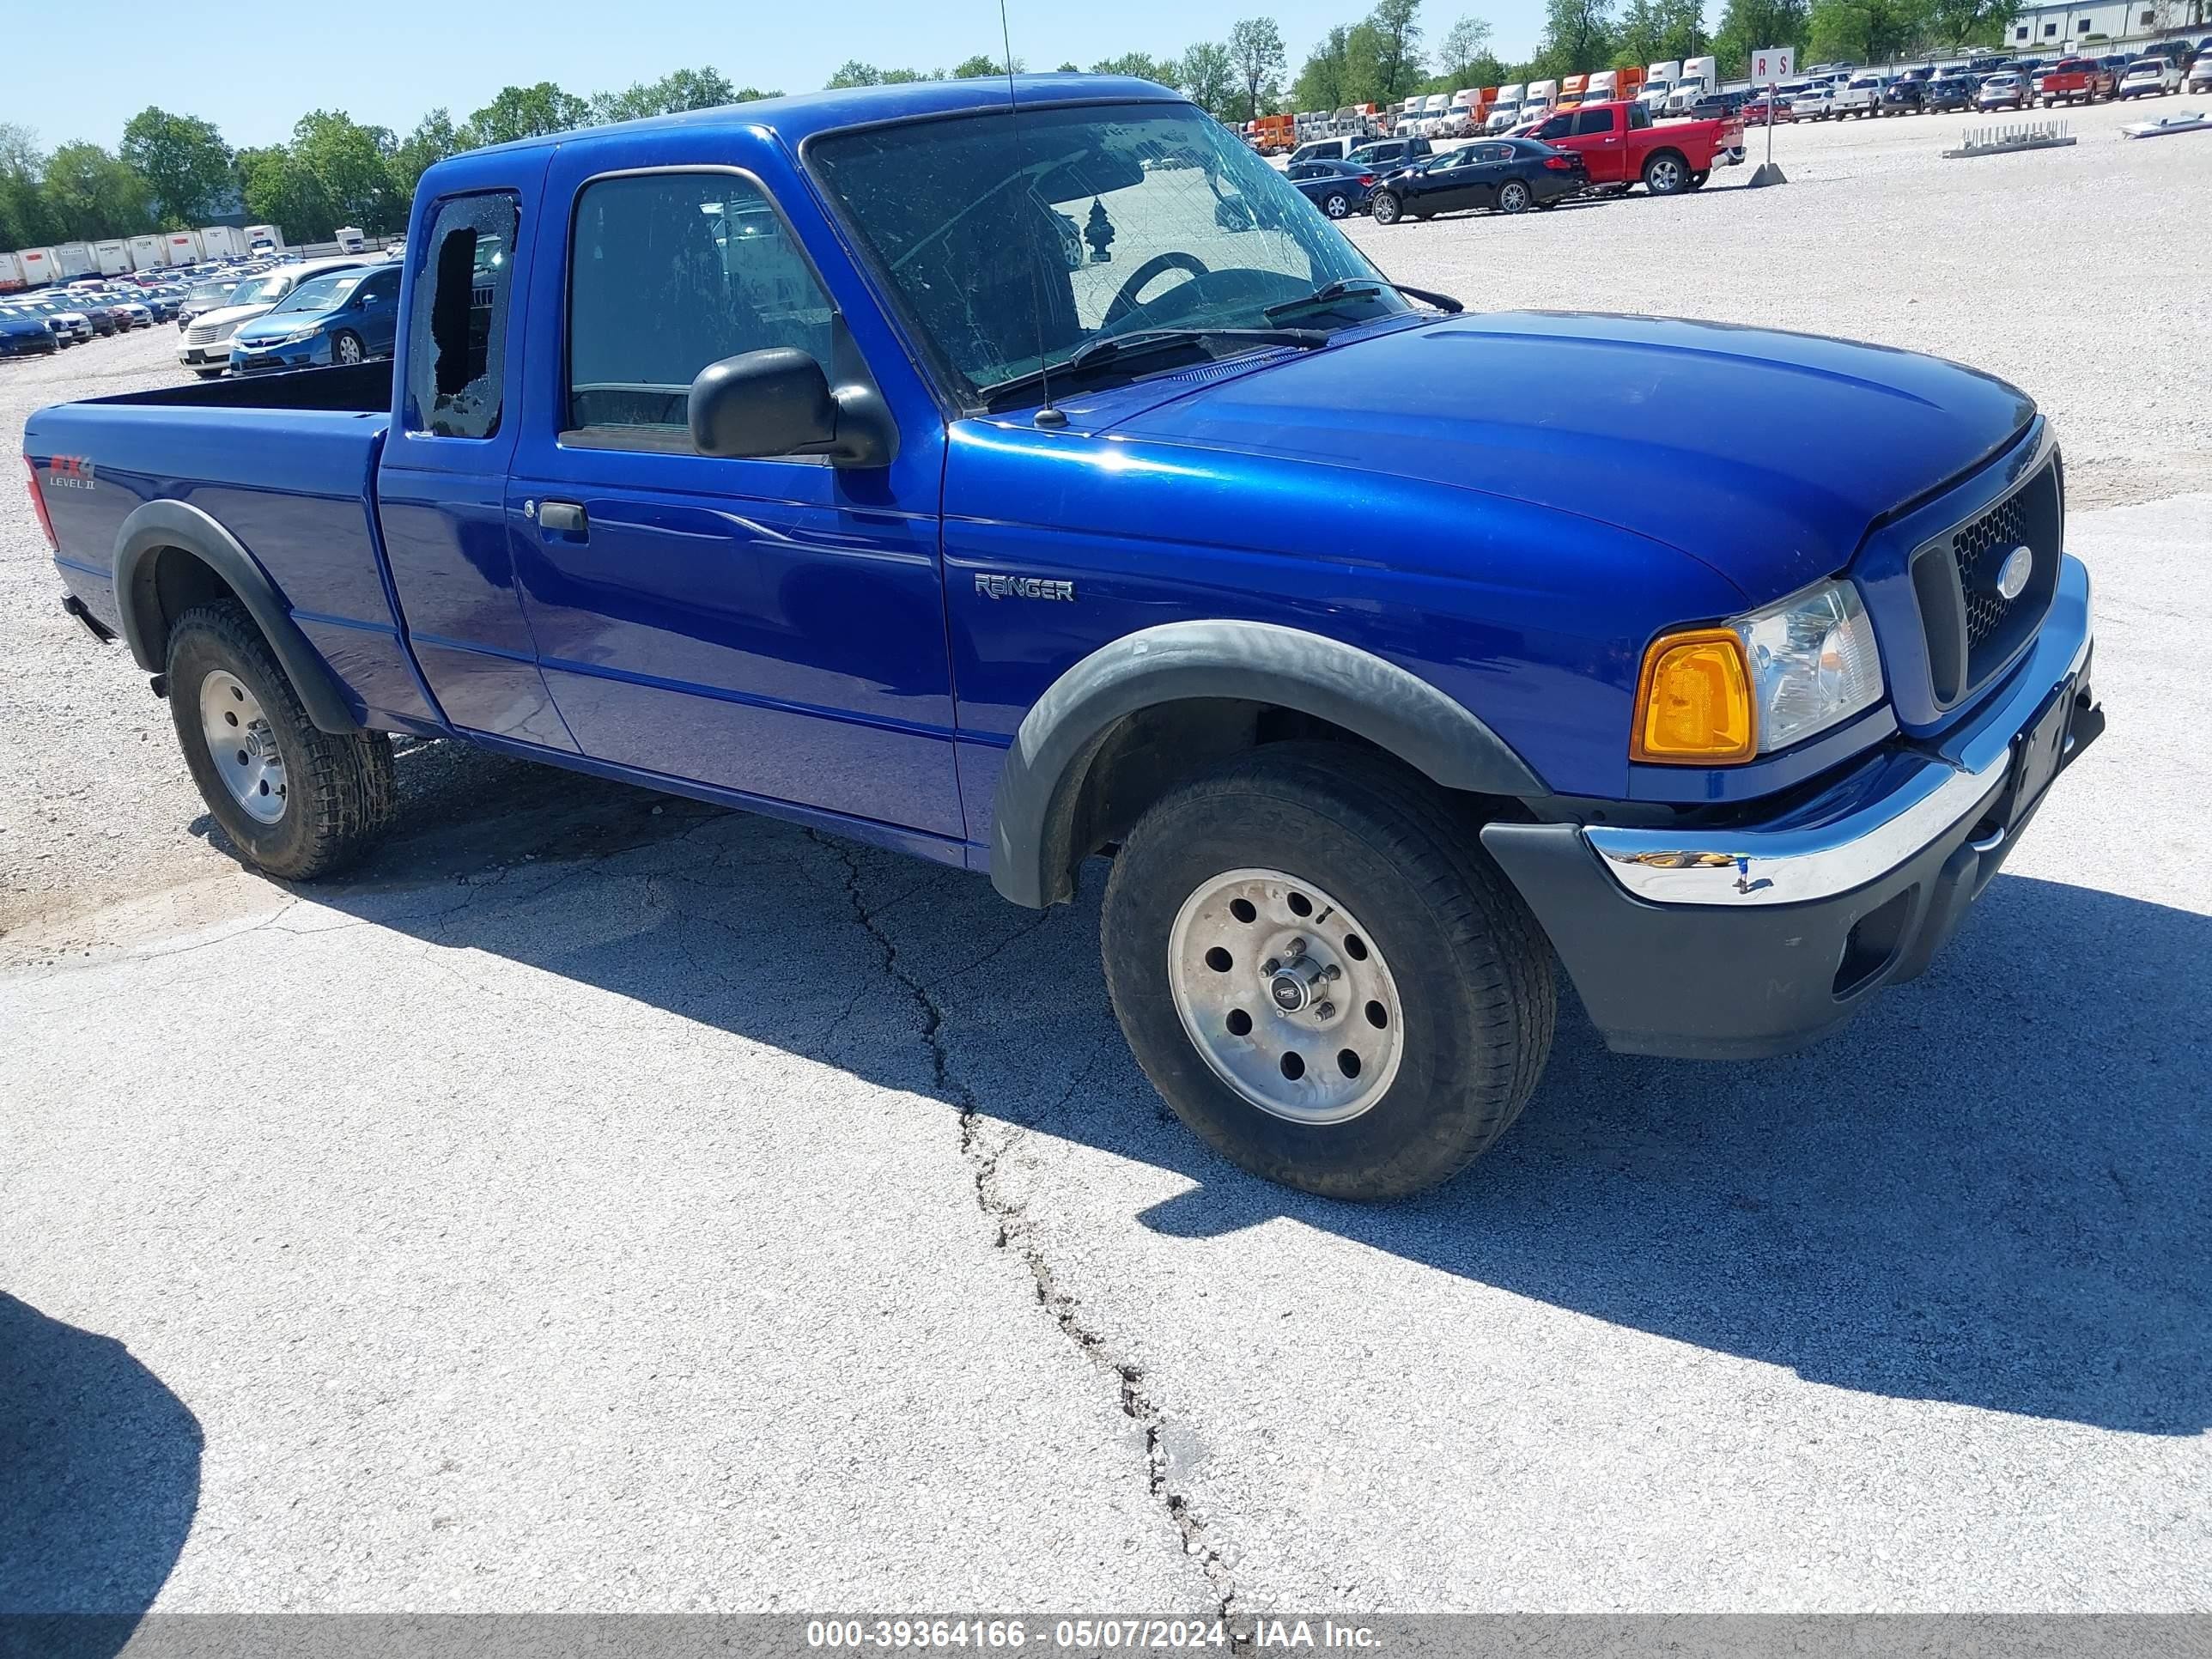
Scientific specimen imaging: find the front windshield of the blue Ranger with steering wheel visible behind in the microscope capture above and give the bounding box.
[807,104,1407,398]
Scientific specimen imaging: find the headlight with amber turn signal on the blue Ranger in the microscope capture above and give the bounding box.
[1631,581,1882,765]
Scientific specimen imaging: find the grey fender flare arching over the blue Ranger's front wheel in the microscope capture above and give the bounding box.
[991,622,1548,909]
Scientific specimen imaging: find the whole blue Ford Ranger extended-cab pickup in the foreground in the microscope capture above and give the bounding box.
[24,76,2104,1197]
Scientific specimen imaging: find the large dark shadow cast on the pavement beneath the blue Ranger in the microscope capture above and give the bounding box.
[298,751,2212,1433]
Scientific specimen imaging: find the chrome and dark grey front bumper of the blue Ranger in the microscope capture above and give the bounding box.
[1482,560,2104,1060]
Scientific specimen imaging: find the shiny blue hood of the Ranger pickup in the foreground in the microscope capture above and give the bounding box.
[1110,312,2035,604]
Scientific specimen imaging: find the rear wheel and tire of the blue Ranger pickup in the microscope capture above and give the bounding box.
[168,599,394,880]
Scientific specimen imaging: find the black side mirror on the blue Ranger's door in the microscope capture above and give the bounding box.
[684,345,898,467]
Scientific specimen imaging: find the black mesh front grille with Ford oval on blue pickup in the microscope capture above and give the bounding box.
[1911,452,2063,708]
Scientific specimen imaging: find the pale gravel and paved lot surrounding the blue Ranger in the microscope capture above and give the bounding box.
[0,100,2212,1610]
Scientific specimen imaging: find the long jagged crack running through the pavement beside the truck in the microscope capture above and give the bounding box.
[807,830,1245,1648]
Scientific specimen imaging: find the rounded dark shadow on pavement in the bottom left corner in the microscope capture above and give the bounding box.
[0,1294,201,1659]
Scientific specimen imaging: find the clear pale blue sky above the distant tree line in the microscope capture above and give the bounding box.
[0,0,1583,149]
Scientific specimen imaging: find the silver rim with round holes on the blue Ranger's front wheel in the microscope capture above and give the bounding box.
[1168,869,1405,1128]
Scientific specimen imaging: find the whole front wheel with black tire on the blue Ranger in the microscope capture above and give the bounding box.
[1099,744,1558,1199]
